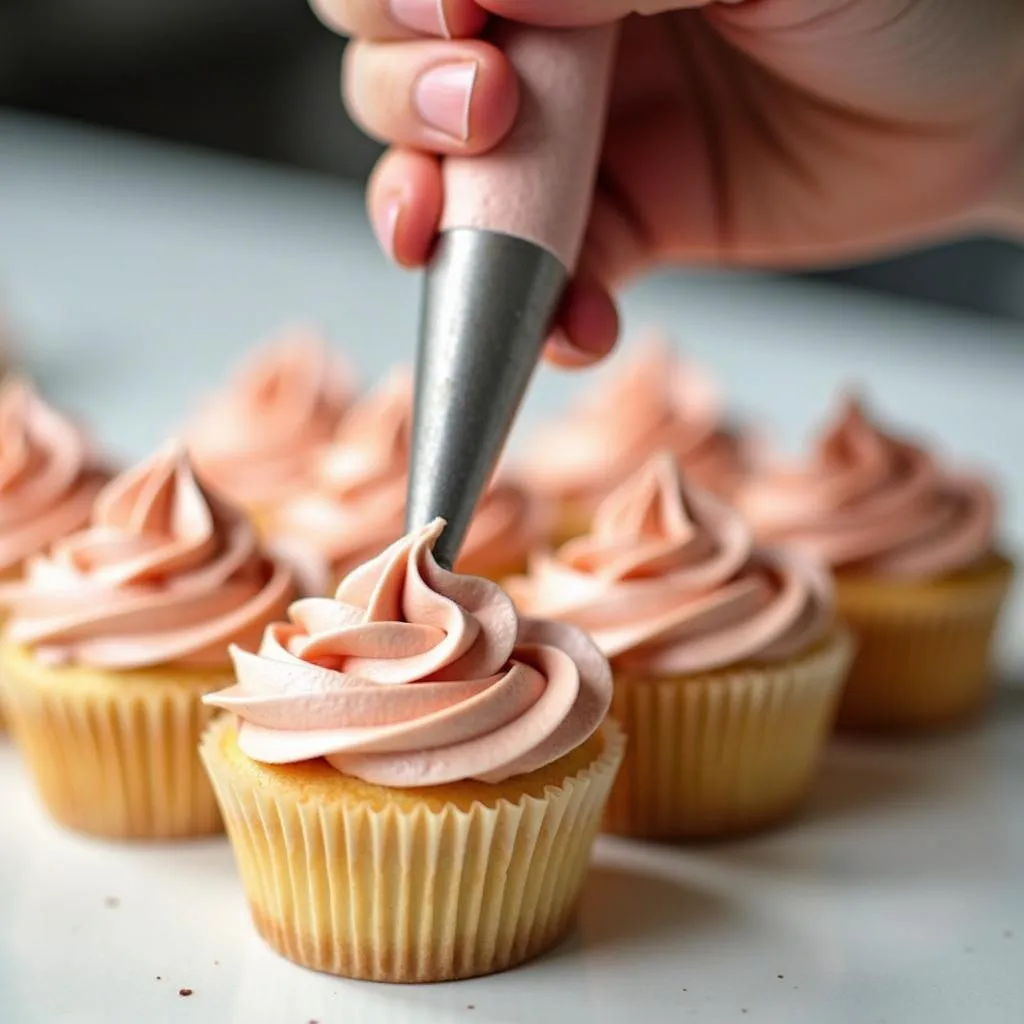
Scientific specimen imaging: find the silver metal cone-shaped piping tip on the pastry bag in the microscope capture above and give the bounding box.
[406,227,568,568]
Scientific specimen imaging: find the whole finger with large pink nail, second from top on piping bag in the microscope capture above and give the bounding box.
[343,40,519,154]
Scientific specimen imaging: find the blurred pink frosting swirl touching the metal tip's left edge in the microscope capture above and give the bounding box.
[268,370,413,590]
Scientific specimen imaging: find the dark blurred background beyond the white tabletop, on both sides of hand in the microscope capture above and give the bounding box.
[0,0,1024,319]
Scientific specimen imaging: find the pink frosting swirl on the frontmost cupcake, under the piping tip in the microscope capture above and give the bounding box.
[206,520,611,787]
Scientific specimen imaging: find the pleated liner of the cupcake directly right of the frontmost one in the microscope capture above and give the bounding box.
[604,630,853,840]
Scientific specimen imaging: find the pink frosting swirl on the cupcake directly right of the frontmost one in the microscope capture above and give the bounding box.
[509,453,834,676]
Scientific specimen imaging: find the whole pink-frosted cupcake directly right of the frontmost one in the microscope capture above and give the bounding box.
[509,453,851,839]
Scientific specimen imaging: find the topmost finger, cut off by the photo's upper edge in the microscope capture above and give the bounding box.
[309,0,486,40]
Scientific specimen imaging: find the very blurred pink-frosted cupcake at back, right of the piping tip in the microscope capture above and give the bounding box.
[521,338,749,541]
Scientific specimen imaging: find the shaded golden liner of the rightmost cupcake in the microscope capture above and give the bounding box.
[837,558,1013,733]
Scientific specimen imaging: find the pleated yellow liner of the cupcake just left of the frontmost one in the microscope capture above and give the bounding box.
[0,649,229,840]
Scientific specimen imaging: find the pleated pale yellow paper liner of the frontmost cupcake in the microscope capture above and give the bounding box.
[201,720,624,982]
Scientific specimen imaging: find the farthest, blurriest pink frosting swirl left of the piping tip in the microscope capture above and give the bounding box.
[186,329,354,506]
